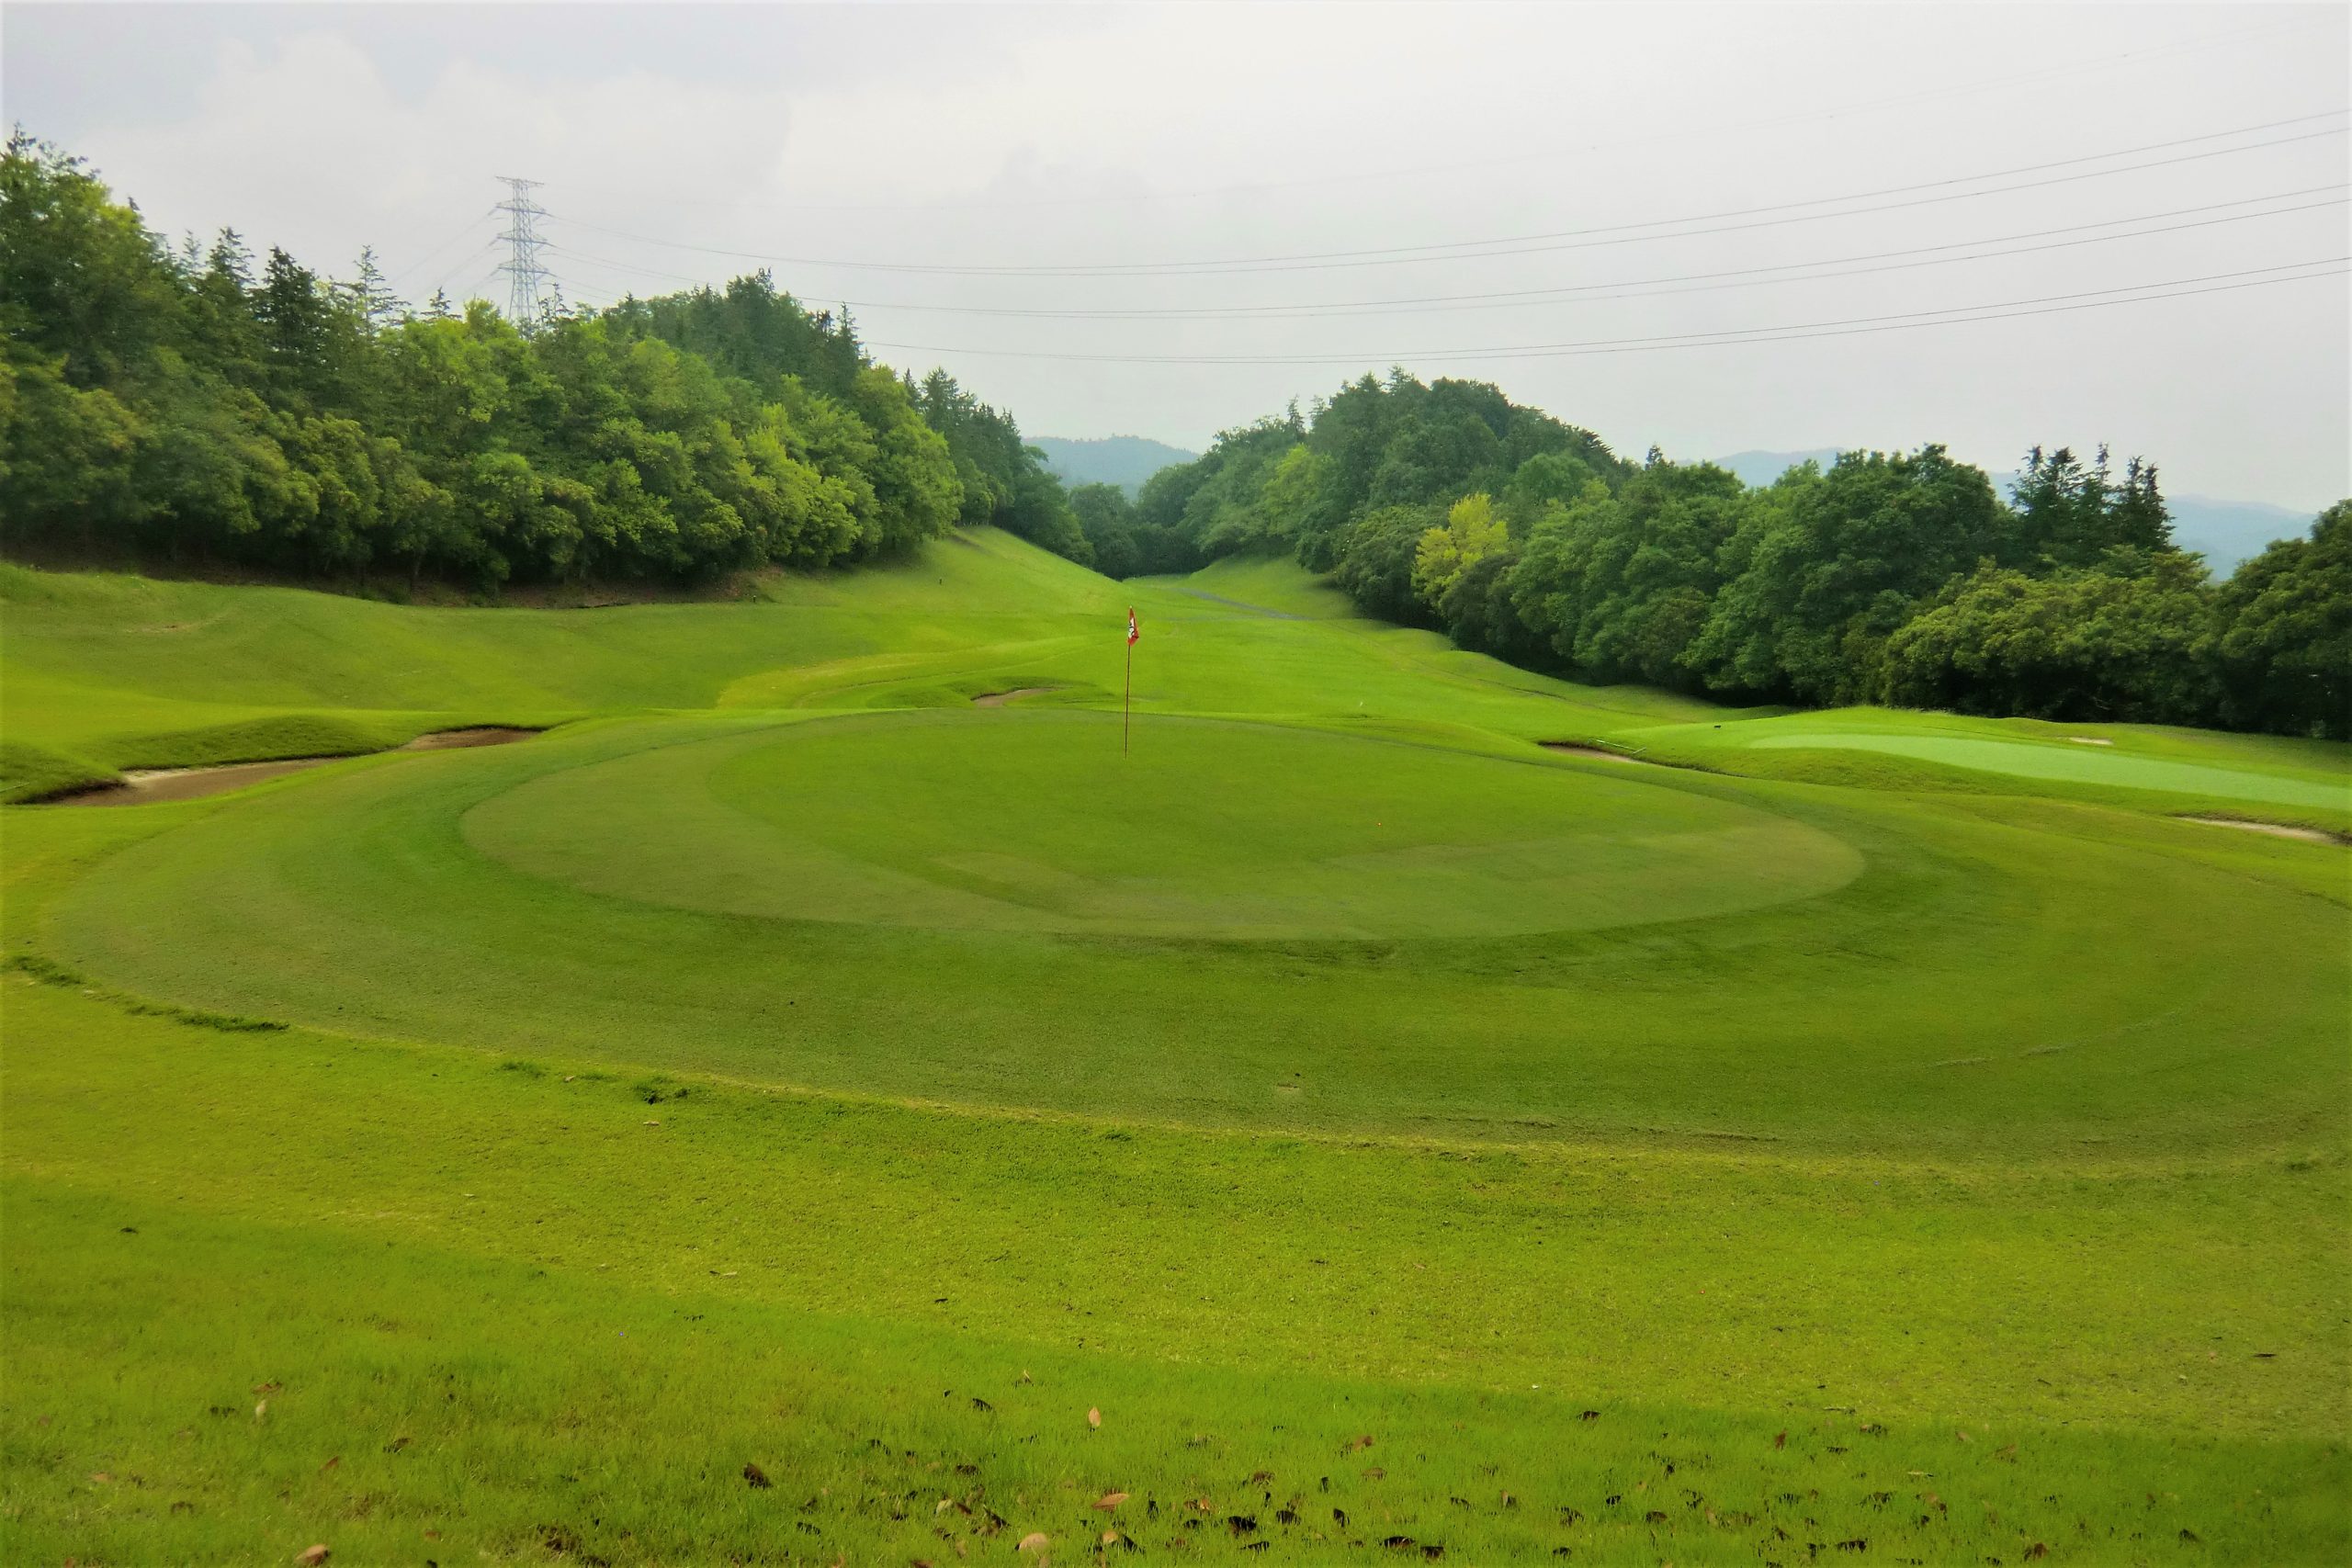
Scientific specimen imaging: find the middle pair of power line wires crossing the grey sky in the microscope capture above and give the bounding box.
[548,184,2345,322]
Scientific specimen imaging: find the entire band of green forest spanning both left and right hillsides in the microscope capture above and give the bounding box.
[0,131,2352,736]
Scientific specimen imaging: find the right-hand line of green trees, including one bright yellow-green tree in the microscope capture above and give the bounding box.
[1072,371,2352,739]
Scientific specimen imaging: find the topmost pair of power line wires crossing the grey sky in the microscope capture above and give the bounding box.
[570,108,2347,277]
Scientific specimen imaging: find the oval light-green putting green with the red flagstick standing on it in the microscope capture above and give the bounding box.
[466,712,1863,938]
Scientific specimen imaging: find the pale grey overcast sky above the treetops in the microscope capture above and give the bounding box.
[0,0,2352,508]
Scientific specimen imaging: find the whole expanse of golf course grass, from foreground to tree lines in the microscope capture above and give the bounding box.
[0,536,2352,1563]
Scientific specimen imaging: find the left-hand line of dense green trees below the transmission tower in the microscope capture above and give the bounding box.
[0,131,1091,588]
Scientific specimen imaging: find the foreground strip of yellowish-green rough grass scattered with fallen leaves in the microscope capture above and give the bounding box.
[5,980,2347,1561]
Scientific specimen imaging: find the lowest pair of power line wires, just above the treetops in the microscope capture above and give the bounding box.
[868,256,2352,365]
